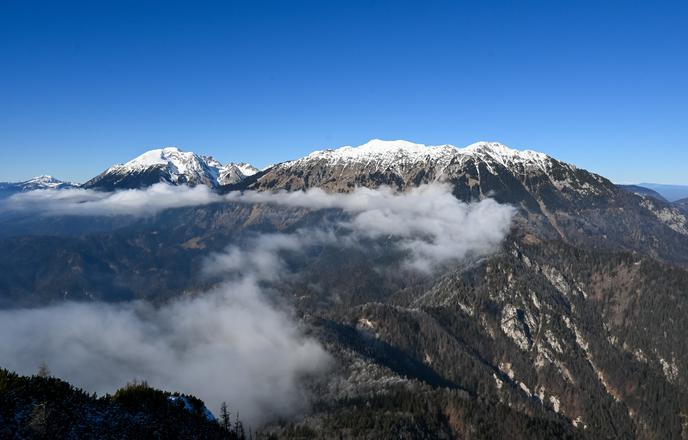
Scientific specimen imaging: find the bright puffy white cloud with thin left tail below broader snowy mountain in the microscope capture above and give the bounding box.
[225,184,515,272]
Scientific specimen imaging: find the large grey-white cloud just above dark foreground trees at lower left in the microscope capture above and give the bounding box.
[0,276,329,424]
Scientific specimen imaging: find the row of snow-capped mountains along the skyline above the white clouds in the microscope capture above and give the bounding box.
[14,140,688,261]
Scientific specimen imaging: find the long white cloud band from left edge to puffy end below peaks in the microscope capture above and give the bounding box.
[0,183,514,271]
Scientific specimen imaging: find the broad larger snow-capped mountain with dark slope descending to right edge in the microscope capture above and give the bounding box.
[231,140,688,258]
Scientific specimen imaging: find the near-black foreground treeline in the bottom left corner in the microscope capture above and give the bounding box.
[0,368,248,440]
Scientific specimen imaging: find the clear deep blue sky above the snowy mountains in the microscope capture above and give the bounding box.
[0,0,688,184]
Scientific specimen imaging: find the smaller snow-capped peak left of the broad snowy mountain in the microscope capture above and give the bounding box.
[83,147,255,191]
